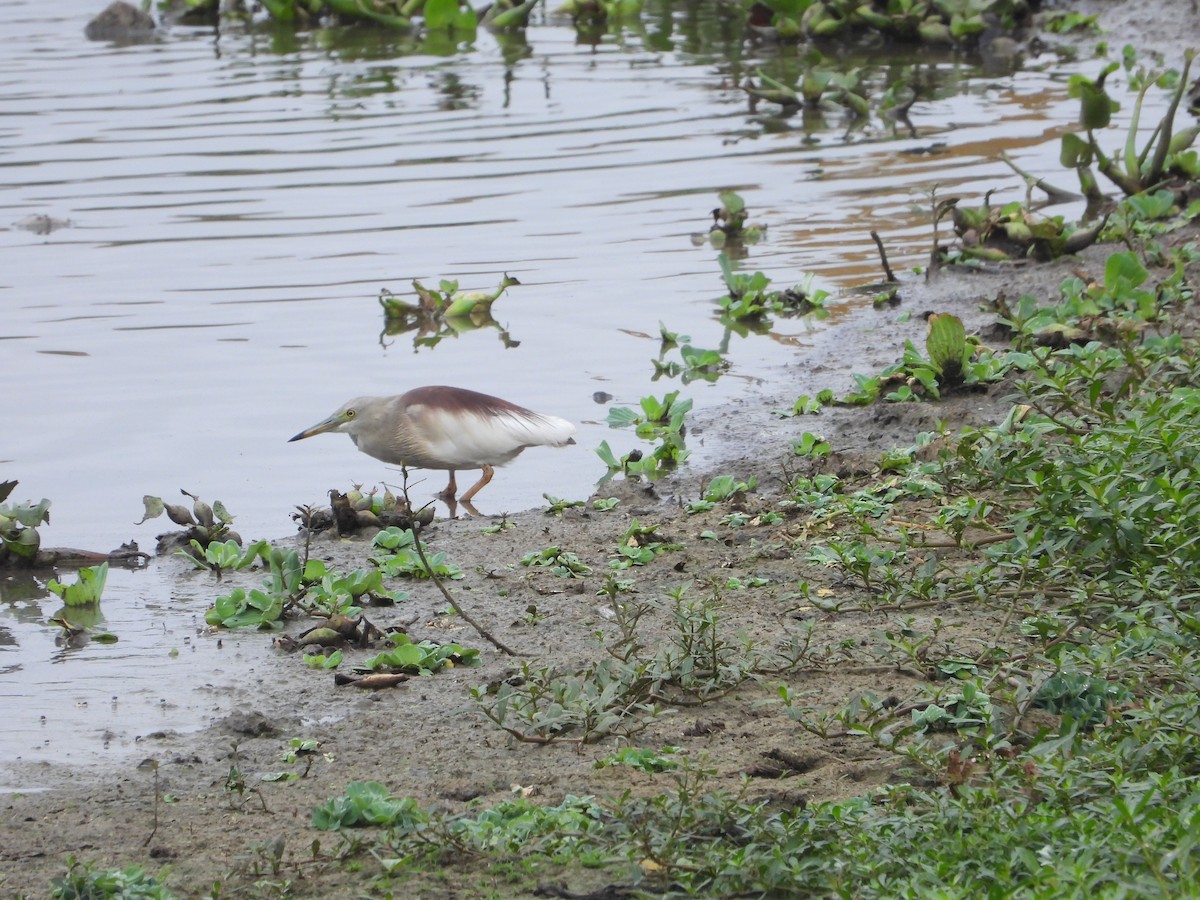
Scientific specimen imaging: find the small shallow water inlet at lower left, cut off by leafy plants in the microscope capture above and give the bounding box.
[0,568,271,792]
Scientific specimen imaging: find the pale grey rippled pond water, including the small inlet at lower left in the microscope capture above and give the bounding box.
[0,0,1166,777]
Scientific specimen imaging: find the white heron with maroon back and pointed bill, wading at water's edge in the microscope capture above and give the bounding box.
[289,385,575,506]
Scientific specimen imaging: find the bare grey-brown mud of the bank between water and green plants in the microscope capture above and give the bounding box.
[0,4,1195,896]
